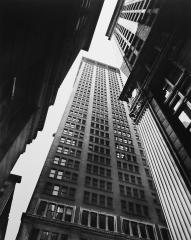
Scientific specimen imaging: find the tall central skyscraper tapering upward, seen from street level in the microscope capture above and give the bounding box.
[16,58,170,240]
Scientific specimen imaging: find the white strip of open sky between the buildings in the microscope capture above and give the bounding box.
[5,0,126,240]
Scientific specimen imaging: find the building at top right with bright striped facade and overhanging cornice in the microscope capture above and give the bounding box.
[106,0,159,71]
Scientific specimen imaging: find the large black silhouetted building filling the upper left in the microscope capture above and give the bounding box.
[0,0,104,195]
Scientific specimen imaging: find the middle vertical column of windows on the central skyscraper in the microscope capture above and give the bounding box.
[84,63,113,209]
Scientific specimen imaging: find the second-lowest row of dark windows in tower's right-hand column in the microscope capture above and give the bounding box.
[119,185,145,200]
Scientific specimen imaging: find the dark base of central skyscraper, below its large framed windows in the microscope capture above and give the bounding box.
[16,214,170,240]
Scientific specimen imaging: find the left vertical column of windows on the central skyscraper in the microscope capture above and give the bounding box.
[47,59,91,202]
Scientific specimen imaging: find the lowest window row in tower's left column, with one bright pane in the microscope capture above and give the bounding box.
[44,182,76,199]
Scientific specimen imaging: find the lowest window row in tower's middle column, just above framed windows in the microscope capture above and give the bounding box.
[84,191,113,208]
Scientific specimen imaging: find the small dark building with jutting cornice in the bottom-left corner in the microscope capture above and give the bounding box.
[0,174,21,240]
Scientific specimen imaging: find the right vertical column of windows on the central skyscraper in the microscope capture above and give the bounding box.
[109,70,151,217]
